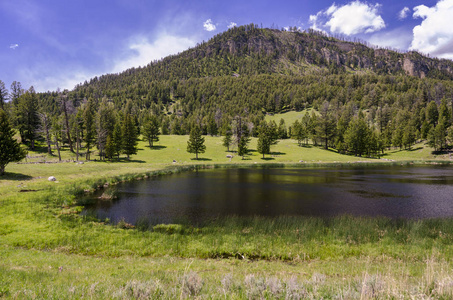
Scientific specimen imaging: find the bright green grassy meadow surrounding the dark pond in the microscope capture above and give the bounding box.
[0,136,453,299]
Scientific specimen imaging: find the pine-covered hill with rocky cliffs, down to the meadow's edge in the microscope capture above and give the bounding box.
[0,25,453,159]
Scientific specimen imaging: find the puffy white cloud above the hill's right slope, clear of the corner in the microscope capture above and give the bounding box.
[309,0,385,35]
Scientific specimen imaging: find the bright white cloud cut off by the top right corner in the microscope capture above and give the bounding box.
[410,0,453,59]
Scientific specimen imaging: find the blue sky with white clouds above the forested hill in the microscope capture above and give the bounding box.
[0,0,453,91]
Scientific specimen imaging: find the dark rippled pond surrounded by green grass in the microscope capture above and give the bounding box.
[83,166,453,223]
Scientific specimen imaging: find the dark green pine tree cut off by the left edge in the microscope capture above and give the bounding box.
[0,109,27,176]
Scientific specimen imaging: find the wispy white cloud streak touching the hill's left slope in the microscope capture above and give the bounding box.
[112,34,196,73]
